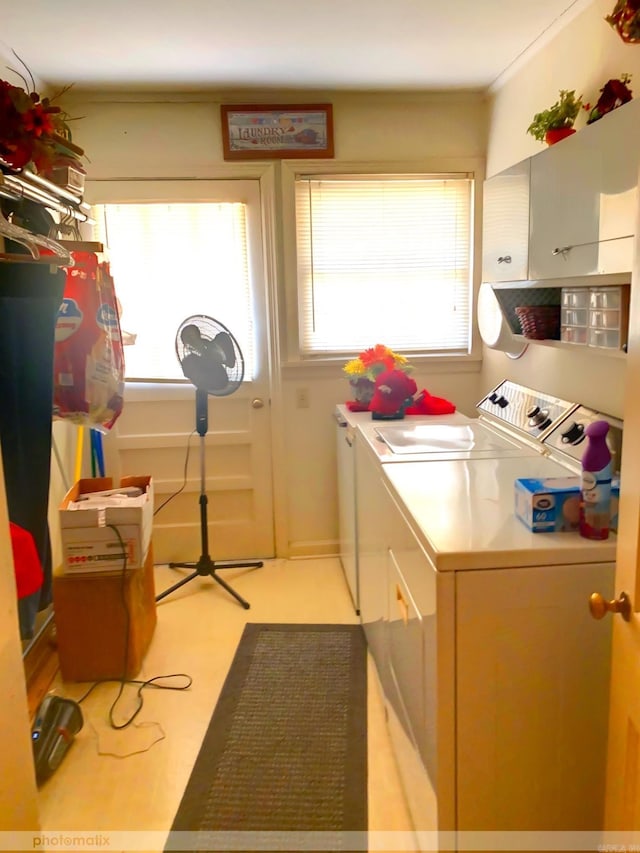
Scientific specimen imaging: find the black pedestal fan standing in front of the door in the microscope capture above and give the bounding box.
[156,314,263,610]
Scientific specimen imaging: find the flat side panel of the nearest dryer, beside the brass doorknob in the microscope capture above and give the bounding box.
[456,564,614,832]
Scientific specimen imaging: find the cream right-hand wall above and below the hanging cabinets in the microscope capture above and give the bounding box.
[481,0,640,417]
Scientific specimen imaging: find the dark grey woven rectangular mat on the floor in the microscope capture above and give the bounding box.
[165,624,367,851]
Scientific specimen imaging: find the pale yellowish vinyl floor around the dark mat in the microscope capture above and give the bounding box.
[39,558,411,849]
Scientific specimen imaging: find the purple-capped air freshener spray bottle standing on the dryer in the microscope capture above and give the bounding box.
[580,421,611,539]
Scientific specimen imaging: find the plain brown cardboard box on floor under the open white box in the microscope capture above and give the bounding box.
[53,545,157,681]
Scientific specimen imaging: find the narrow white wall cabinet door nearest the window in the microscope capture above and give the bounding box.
[482,160,529,281]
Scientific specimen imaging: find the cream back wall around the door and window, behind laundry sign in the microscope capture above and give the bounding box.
[66,92,486,556]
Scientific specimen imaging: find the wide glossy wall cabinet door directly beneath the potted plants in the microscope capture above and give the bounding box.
[528,101,640,280]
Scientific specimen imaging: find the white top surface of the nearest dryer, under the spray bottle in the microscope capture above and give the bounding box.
[382,456,616,571]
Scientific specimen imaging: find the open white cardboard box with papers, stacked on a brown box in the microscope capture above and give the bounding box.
[59,476,153,573]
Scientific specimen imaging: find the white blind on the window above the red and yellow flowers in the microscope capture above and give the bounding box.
[296,175,472,356]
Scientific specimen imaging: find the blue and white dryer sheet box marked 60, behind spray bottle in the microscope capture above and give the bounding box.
[515,477,620,533]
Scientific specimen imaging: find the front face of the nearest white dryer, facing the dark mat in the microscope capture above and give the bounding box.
[387,480,455,829]
